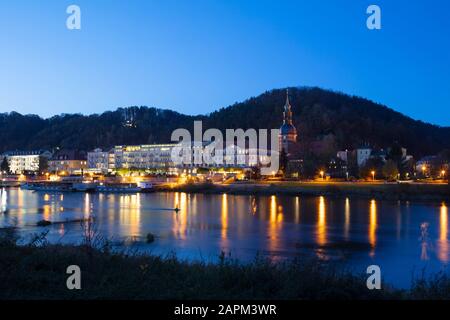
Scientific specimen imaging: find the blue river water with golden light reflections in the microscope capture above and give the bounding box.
[0,189,450,287]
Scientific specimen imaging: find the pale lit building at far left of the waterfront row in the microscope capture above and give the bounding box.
[2,150,52,174]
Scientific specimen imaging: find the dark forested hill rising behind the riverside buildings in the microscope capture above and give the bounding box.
[0,88,450,156]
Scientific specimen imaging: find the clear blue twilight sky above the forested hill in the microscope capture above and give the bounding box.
[0,0,450,126]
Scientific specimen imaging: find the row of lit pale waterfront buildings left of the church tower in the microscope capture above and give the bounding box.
[0,143,270,175]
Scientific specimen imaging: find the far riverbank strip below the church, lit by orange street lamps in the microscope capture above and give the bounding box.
[155,181,450,201]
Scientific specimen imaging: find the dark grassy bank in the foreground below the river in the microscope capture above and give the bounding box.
[0,230,450,300]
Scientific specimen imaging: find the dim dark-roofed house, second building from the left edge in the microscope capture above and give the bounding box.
[48,150,87,174]
